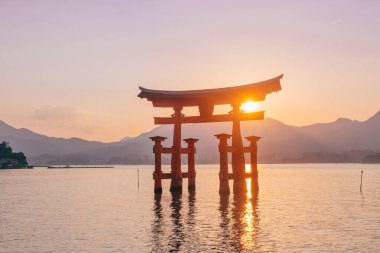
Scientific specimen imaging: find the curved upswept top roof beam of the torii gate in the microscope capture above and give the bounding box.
[138,75,283,107]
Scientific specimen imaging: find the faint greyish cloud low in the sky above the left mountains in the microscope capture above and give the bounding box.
[33,106,79,121]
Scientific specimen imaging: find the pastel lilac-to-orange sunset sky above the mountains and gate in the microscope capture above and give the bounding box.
[0,0,380,141]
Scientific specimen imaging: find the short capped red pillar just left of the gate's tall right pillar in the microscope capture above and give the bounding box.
[215,134,231,194]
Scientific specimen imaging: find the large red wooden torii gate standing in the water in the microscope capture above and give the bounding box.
[138,75,282,193]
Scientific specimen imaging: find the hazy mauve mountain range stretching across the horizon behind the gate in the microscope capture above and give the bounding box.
[0,112,380,164]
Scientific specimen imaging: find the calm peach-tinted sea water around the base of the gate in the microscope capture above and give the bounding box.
[0,164,380,253]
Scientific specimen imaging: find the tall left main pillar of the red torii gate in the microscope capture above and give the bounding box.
[170,107,182,192]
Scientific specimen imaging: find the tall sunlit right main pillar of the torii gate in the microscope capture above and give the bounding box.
[232,104,247,193]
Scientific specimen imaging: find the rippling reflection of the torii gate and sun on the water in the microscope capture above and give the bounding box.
[151,164,261,252]
